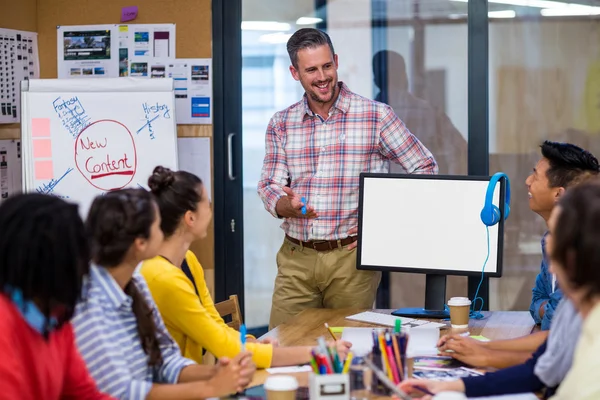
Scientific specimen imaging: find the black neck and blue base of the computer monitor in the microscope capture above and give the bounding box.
[392,274,450,319]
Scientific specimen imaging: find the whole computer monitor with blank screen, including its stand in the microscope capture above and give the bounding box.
[356,173,506,318]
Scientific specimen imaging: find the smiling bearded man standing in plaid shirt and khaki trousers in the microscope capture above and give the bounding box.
[258,28,438,328]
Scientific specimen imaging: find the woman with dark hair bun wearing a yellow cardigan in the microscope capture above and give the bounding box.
[141,167,351,368]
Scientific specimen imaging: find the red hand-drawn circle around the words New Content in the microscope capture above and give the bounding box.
[75,119,137,191]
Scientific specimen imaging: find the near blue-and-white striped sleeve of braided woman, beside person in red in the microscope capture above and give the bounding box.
[73,302,152,400]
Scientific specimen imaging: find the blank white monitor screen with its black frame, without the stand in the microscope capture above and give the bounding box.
[359,177,500,273]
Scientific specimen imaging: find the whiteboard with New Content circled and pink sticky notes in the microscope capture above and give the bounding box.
[21,78,177,216]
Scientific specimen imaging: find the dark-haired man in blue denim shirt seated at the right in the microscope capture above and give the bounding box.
[525,141,599,330]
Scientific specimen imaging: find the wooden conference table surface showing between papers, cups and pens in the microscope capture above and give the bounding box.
[250,308,538,386]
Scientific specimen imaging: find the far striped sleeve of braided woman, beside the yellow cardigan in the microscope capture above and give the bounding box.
[134,272,196,383]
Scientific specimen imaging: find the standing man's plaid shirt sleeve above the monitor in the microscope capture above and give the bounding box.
[379,106,438,175]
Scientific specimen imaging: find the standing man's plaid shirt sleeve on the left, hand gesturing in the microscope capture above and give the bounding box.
[258,115,289,218]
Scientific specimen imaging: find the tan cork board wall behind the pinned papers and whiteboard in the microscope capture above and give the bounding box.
[0,0,214,292]
